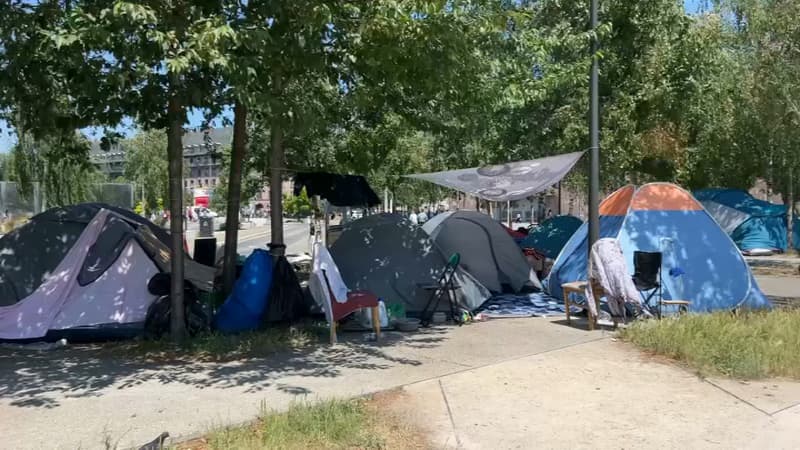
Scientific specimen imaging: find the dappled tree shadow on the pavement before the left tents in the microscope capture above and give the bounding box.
[0,328,447,408]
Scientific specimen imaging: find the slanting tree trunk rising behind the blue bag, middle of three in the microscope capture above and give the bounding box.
[222,103,247,295]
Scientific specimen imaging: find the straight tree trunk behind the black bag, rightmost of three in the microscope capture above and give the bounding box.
[269,72,286,256]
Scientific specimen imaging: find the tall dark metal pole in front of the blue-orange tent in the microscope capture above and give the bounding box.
[589,0,600,252]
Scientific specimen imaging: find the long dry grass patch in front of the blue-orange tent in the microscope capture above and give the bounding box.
[621,310,800,379]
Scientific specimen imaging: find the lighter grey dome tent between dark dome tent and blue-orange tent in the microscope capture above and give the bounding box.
[422,210,541,293]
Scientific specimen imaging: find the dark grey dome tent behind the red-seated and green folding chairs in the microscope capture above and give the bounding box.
[330,214,490,314]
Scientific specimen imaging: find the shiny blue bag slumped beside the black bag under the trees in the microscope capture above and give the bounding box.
[214,249,272,333]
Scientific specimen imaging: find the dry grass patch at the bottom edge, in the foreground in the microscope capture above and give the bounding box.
[182,392,426,450]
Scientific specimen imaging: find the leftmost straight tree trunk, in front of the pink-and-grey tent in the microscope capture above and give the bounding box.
[167,87,186,341]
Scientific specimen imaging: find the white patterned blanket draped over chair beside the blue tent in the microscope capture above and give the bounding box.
[586,238,642,317]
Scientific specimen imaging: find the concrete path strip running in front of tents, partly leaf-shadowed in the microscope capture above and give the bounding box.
[0,320,607,449]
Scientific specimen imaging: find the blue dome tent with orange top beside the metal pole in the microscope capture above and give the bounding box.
[548,183,769,311]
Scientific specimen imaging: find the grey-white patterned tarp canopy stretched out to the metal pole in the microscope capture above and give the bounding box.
[406,152,584,202]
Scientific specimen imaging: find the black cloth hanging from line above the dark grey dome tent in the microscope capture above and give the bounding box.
[294,172,381,207]
